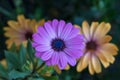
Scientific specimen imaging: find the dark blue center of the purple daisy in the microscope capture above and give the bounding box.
[51,39,65,51]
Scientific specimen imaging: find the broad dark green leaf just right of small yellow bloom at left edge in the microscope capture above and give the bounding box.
[5,51,20,69]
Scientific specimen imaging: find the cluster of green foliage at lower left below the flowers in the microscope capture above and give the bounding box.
[0,40,57,80]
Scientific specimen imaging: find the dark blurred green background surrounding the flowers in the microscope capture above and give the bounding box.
[0,0,120,80]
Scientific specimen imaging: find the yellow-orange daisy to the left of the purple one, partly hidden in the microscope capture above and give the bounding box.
[4,15,44,48]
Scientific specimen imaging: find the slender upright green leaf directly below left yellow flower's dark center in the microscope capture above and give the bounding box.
[27,40,34,64]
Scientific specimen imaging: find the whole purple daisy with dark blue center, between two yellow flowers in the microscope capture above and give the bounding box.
[32,19,85,69]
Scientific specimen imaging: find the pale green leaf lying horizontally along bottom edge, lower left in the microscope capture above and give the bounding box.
[9,70,30,79]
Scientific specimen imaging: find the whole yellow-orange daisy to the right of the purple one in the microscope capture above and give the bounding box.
[76,21,118,75]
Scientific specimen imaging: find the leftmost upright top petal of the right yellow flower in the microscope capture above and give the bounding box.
[82,21,90,40]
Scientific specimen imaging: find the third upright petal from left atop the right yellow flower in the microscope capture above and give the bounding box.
[93,22,105,40]
